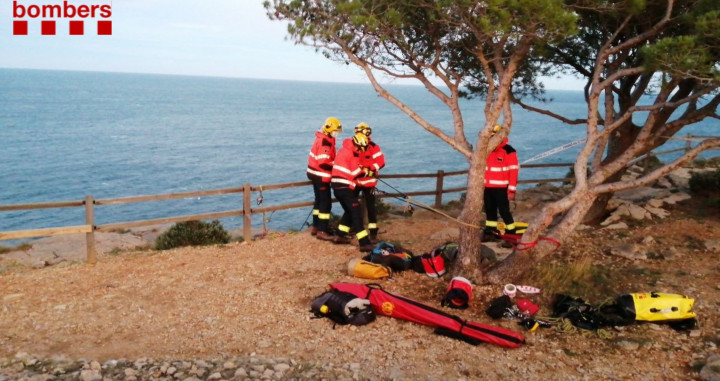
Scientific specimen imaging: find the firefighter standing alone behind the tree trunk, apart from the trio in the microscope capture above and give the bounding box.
[484,125,520,238]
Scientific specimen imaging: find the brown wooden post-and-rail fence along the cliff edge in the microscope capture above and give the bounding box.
[0,135,716,263]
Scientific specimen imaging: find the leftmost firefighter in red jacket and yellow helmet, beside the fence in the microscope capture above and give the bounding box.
[307,117,342,241]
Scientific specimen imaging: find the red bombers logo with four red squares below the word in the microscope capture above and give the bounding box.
[13,0,112,36]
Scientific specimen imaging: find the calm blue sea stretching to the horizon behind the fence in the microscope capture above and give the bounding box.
[0,69,718,238]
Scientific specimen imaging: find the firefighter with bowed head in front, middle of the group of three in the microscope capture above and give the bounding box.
[331,133,375,251]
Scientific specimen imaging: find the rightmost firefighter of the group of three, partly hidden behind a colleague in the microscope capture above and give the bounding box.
[355,123,385,243]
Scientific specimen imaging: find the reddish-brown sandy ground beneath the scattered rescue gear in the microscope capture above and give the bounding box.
[0,199,720,381]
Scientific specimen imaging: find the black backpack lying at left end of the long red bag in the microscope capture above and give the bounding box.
[310,289,375,325]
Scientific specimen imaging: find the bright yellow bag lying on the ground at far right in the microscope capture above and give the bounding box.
[618,292,696,322]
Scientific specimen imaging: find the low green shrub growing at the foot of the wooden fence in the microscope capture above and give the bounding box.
[155,220,230,250]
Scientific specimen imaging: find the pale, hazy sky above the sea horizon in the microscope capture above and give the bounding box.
[0,0,582,90]
